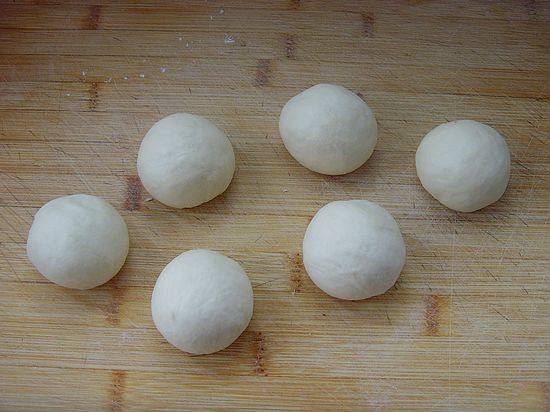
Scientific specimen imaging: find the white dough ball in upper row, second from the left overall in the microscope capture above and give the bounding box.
[137,113,235,208]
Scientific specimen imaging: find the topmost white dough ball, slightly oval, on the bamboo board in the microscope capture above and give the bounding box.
[279,84,377,175]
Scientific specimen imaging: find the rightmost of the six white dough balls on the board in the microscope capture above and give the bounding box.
[416,120,510,212]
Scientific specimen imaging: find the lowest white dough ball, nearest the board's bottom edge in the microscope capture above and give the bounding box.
[151,249,254,355]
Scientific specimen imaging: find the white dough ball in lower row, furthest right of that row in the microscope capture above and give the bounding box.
[303,200,405,300]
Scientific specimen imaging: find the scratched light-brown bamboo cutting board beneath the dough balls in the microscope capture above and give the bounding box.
[0,0,550,411]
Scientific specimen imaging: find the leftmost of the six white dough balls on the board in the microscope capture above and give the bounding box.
[27,195,129,289]
